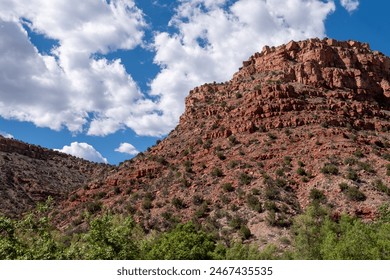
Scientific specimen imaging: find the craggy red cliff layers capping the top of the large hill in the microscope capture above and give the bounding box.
[180,39,390,138]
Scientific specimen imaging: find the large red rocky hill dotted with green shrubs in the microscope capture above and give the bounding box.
[1,39,390,241]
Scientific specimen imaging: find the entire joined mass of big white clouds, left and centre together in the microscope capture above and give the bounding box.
[0,0,338,136]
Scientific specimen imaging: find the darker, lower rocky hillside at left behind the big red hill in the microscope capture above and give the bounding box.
[0,136,109,216]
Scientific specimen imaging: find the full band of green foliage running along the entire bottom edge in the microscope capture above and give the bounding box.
[0,199,390,260]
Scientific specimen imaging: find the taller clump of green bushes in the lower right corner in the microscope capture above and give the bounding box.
[289,205,390,260]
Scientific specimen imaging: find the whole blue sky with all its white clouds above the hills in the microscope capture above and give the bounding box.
[0,0,390,164]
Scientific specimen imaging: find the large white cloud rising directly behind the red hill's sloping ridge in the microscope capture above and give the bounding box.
[149,0,335,131]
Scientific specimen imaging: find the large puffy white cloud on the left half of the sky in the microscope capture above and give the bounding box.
[0,0,153,135]
